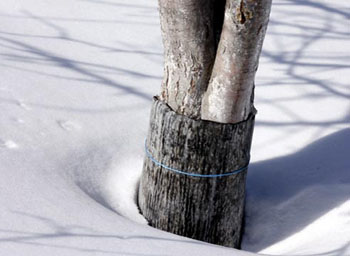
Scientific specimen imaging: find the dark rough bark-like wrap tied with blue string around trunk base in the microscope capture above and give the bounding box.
[138,97,255,248]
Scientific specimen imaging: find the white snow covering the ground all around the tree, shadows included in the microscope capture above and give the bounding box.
[0,0,350,256]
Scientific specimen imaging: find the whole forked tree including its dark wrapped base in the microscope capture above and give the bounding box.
[138,0,271,247]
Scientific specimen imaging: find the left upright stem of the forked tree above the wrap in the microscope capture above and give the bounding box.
[159,0,220,118]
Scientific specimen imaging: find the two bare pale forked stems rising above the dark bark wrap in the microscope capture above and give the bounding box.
[159,0,271,123]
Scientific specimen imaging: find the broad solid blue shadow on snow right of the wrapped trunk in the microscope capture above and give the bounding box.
[243,129,350,253]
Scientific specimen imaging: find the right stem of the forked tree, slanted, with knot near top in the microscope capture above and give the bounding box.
[201,0,271,123]
